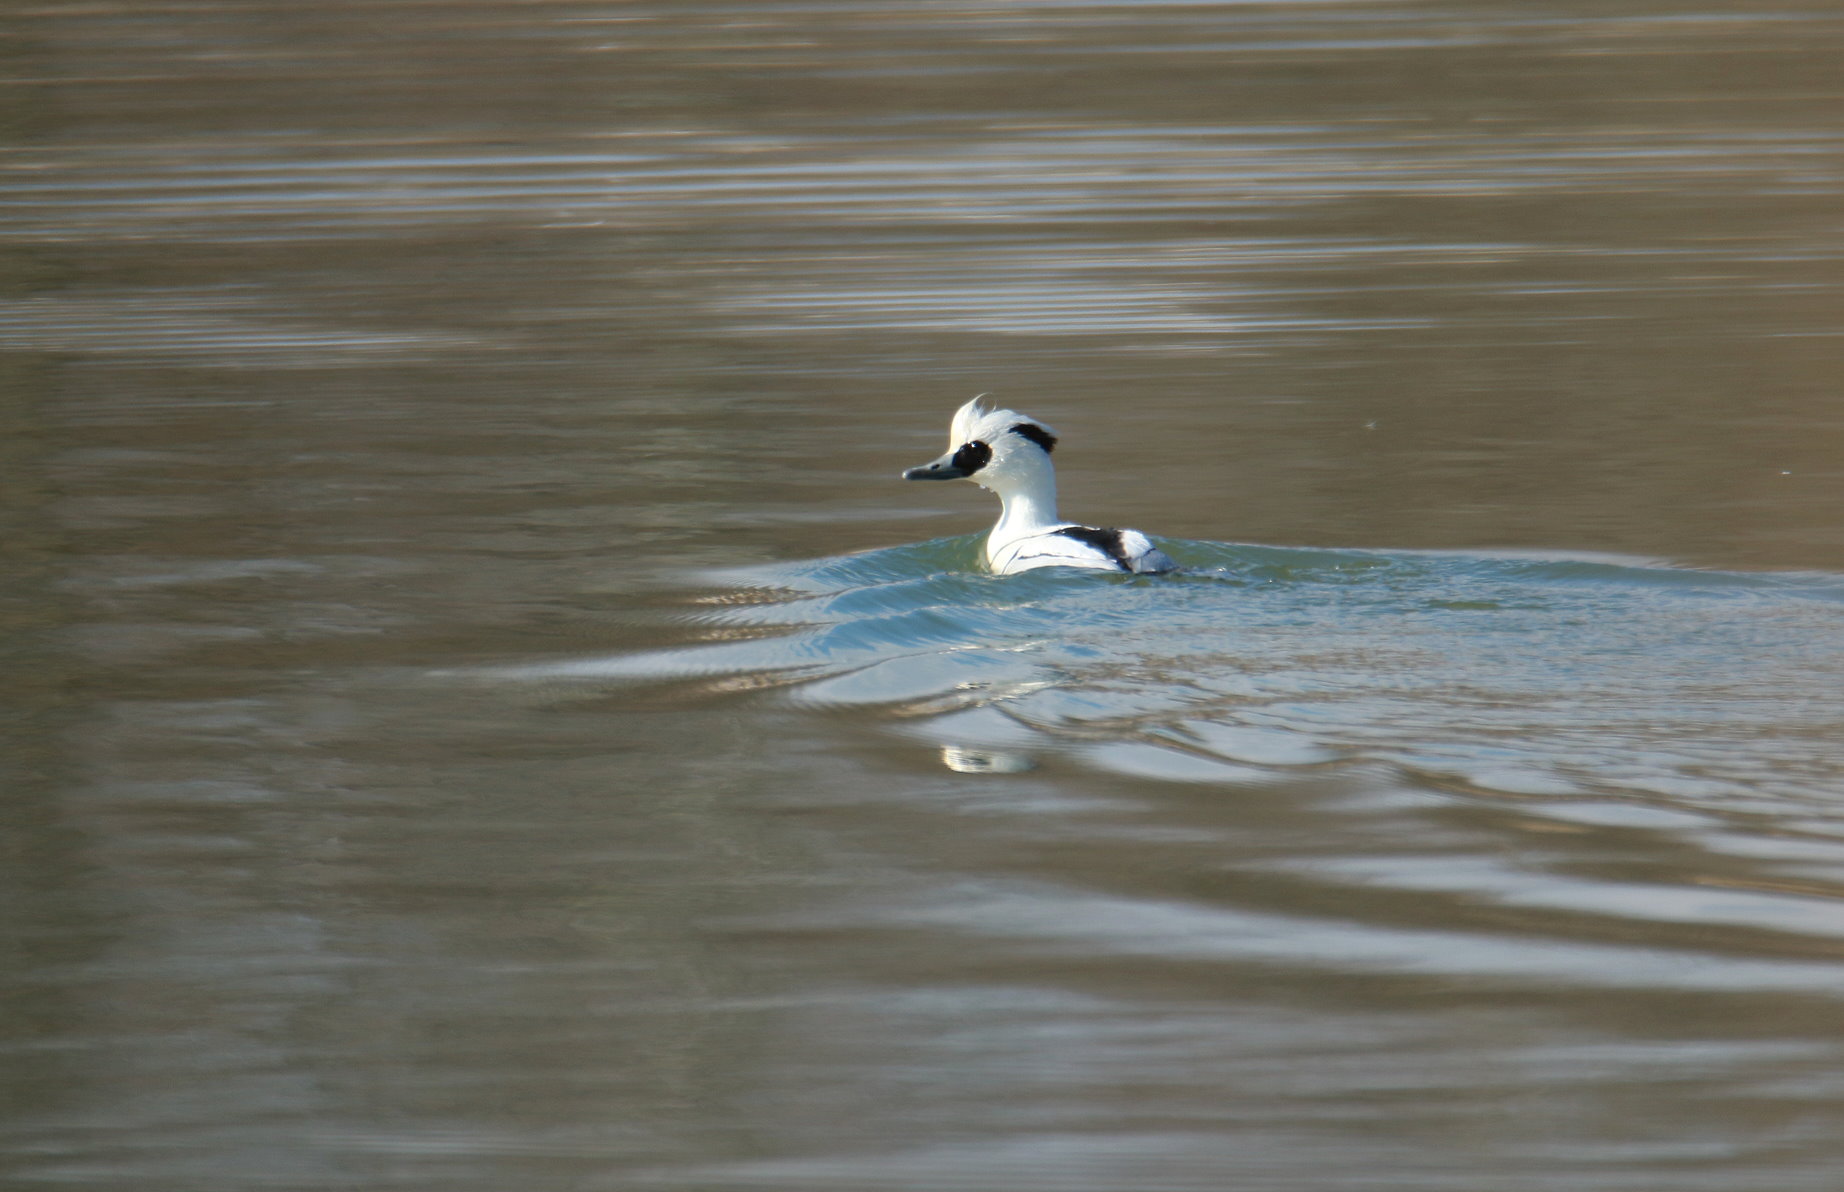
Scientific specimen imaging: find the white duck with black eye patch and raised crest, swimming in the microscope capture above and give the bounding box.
[904,393,1176,576]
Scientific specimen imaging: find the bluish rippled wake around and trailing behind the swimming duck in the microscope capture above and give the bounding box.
[507,537,1844,811]
